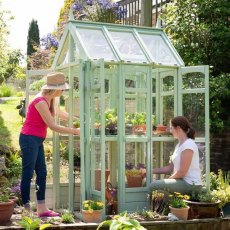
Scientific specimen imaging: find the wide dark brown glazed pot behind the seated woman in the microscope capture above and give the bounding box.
[186,200,219,219]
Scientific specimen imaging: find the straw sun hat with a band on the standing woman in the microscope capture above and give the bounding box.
[42,72,70,90]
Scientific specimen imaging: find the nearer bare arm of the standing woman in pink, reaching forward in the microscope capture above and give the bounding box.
[35,101,80,135]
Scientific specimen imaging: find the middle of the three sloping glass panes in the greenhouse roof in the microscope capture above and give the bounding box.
[109,31,148,62]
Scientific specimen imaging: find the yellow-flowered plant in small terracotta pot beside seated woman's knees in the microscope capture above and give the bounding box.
[169,192,189,220]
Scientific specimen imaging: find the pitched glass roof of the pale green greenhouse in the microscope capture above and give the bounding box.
[54,20,184,66]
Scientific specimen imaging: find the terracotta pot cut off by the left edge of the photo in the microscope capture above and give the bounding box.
[0,200,15,225]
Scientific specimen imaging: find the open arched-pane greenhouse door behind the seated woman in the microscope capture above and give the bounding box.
[178,66,210,186]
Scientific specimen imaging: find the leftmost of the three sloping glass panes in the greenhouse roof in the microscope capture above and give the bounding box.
[76,27,117,61]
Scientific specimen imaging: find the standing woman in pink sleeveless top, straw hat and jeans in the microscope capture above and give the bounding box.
[19,72,80,217]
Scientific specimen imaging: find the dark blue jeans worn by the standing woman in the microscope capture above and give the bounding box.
[19,133,47,205]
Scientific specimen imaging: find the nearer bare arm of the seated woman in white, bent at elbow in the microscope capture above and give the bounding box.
[169,149,193,179]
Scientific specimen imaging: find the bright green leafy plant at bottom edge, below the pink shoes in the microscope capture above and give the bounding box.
[18,216,51,230]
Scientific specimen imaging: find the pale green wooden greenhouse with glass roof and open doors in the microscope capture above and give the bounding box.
[27,20,210,216]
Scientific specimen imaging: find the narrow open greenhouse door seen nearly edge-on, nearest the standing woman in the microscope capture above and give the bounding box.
[81,60,106,208]
